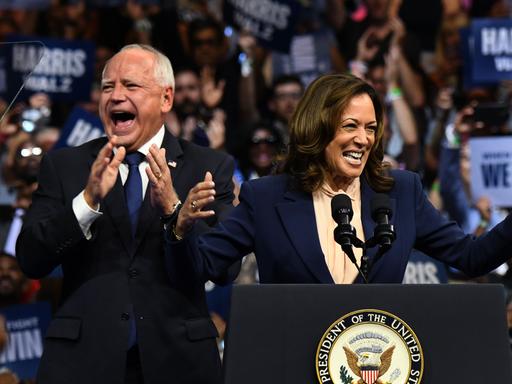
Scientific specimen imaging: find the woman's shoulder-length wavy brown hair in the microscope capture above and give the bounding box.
[283,74,394,192]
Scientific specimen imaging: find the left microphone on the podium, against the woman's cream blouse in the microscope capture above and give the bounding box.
[331,194,367,282]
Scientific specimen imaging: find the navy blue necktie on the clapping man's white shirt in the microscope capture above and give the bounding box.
[124,152,144,236]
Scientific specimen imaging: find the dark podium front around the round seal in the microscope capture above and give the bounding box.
[224,284,512,384]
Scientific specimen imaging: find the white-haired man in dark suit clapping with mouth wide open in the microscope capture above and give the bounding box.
[17,45,233,384]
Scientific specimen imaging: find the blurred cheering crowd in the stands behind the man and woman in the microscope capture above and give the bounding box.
[0,0,512,383]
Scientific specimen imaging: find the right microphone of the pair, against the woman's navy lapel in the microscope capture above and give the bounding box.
[370,193,396,253]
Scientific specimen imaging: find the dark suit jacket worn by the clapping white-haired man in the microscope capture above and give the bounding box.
[17,132,234,384]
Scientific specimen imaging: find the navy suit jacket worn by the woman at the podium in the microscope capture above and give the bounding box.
[176,171,512,284]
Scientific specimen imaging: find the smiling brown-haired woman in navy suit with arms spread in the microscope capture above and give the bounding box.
[168,74,512,284]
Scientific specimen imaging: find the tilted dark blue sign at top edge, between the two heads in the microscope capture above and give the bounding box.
[224,0,302,52]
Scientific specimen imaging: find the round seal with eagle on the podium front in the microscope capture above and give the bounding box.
[315,309,423,384]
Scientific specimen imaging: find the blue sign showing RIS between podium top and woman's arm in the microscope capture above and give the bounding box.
[403,249,448,284]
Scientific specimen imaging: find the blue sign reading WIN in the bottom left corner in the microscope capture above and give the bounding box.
[0,302,51,380]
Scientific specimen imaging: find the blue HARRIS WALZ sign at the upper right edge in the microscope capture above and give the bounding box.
[470,19,512,83]
